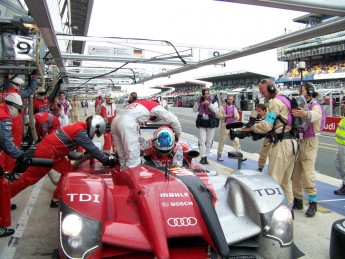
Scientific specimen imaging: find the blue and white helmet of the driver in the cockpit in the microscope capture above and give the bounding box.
[153,126,175,155]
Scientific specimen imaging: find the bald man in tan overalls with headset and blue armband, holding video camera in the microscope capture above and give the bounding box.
[242,79,297,207]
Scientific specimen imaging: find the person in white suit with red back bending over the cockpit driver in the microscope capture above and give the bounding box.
[111,100,182,170]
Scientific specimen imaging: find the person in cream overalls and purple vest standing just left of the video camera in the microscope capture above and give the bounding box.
[216,95,247,162]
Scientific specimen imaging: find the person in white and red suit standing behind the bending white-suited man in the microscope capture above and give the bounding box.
[100,93,116,154]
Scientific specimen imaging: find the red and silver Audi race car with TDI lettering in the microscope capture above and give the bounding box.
[59,126,294,259]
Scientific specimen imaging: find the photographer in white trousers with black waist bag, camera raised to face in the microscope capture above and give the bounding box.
[193,89,219,165]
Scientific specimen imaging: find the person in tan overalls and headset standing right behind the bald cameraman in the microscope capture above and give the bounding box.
[292,82,322,217]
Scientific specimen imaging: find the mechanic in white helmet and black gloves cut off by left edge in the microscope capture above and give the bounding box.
[0,93,31,237]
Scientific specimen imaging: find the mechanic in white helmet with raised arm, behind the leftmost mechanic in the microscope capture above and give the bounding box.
[0,70,37,172]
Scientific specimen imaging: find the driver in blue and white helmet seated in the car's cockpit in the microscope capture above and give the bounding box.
[140,126,183,167]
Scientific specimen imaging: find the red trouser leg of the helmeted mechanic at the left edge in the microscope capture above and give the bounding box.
[0,168,11,227]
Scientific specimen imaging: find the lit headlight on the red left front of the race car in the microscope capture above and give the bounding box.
[59,201,102,258]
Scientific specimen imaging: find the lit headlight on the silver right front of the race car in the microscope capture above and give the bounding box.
[262,205,293,246]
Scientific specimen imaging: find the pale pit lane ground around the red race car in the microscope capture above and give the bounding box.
[0,107,345,259]
